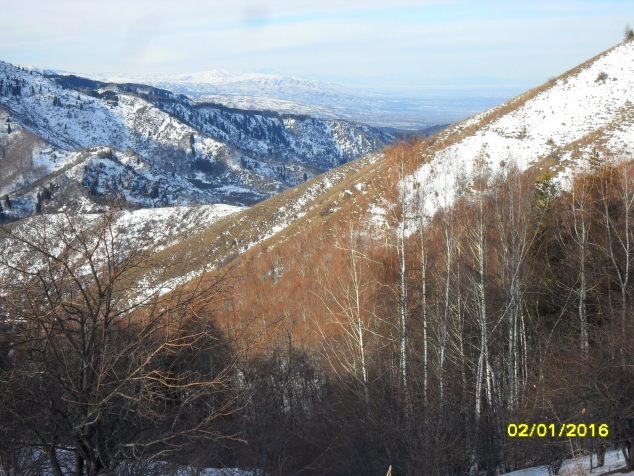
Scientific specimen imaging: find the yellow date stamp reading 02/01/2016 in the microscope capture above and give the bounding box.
[506,423,610,438]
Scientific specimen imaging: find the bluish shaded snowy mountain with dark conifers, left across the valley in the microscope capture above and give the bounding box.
[0,63,392,217]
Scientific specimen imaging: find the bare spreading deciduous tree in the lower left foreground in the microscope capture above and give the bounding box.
[0,208,236,476]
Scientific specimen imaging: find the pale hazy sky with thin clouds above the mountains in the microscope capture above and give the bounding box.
[0,0,634,91]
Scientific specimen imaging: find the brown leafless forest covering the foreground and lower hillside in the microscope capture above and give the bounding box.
[0,144,634,474]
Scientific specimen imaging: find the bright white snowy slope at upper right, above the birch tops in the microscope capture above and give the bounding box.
[404,42,634,216]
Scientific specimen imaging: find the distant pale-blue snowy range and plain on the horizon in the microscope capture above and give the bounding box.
[80,70,509,130]
